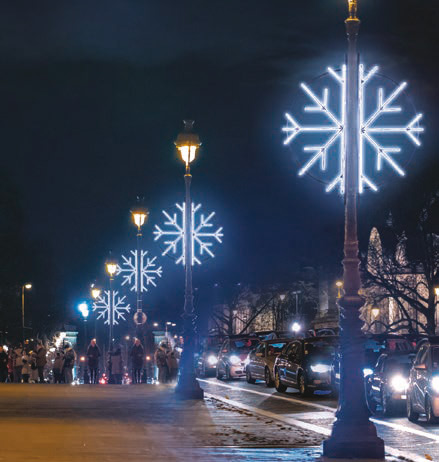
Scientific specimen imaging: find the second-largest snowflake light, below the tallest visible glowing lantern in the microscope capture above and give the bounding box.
[154,203,223,265]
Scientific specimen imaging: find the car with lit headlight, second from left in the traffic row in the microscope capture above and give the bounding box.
[216,336,259,380]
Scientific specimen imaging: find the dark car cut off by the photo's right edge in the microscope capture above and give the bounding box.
[407,337,439,423]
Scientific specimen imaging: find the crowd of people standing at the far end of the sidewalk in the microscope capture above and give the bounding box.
[0,339,179,384]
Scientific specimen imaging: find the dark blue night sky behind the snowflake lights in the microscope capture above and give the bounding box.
[0,0,439,332]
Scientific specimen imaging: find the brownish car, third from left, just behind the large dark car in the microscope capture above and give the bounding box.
[245,339,290,387]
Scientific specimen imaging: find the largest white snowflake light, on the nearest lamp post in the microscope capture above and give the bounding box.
[282,64,424,194]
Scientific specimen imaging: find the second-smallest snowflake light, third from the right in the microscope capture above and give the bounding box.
[116,250,163,292]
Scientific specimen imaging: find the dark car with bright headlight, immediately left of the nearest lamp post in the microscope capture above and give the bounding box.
[274,336,338,396]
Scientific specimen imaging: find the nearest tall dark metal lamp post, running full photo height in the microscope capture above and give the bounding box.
[323,0,384,460]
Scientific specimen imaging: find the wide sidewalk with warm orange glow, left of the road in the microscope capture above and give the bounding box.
[0,384,410,462]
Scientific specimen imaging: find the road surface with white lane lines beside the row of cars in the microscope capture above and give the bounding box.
[201,378,439,462]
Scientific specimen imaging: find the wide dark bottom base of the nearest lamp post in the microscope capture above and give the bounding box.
[322,422,385,462]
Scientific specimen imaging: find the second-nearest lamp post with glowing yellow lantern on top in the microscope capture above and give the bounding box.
[175,120,204,399]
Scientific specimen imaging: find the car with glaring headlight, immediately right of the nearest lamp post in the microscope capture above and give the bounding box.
[366,352,415,416]
